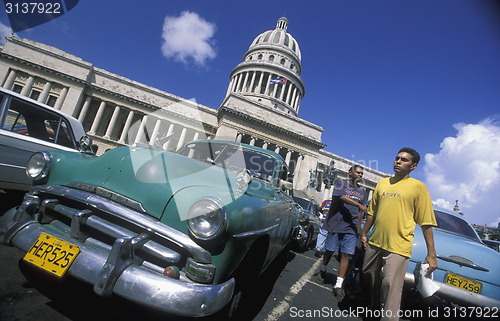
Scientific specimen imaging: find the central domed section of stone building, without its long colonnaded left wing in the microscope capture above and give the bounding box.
[216,17,348,198]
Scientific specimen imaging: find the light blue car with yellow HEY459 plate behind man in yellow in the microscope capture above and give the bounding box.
[405,207,500,308]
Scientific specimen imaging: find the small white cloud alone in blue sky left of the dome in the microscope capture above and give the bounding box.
[161,11,216,66]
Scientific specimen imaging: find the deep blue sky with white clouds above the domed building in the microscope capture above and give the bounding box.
[0,0,500,226]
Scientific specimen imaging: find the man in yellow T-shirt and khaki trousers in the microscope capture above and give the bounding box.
[361,147,437,320]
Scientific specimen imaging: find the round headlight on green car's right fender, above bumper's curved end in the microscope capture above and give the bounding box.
[188,198,226,240]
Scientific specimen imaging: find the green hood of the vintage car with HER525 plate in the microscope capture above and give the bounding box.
[49,147,241,218]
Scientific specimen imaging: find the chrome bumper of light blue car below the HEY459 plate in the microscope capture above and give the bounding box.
[405,272,500,308]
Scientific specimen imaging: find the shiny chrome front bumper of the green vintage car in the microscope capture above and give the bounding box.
[0,202,235,317]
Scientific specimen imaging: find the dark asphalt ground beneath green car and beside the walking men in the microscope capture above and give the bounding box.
[0,239,368,321]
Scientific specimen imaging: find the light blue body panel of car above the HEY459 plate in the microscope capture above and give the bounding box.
[411,226,500,285]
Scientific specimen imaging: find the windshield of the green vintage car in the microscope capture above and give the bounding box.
[178,142,276,181]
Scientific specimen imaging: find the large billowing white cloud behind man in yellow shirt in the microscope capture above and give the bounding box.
[424,115,500,227]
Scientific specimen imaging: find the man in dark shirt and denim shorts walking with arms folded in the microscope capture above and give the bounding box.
[318,165,366,302]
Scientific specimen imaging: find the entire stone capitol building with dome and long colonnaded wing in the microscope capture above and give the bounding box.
[0,17,387,202]
